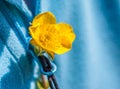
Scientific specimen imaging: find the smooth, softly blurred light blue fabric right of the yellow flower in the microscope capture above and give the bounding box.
[41,0,120,89]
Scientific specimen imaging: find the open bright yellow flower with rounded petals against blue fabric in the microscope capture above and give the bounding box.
[29,12,75,56]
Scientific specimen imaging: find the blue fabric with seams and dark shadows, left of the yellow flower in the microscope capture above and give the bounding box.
[0,0,40,89]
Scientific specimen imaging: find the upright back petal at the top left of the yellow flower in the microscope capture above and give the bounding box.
[32,12,56,26]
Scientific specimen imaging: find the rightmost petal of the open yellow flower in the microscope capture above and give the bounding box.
[55,23,75,54]
